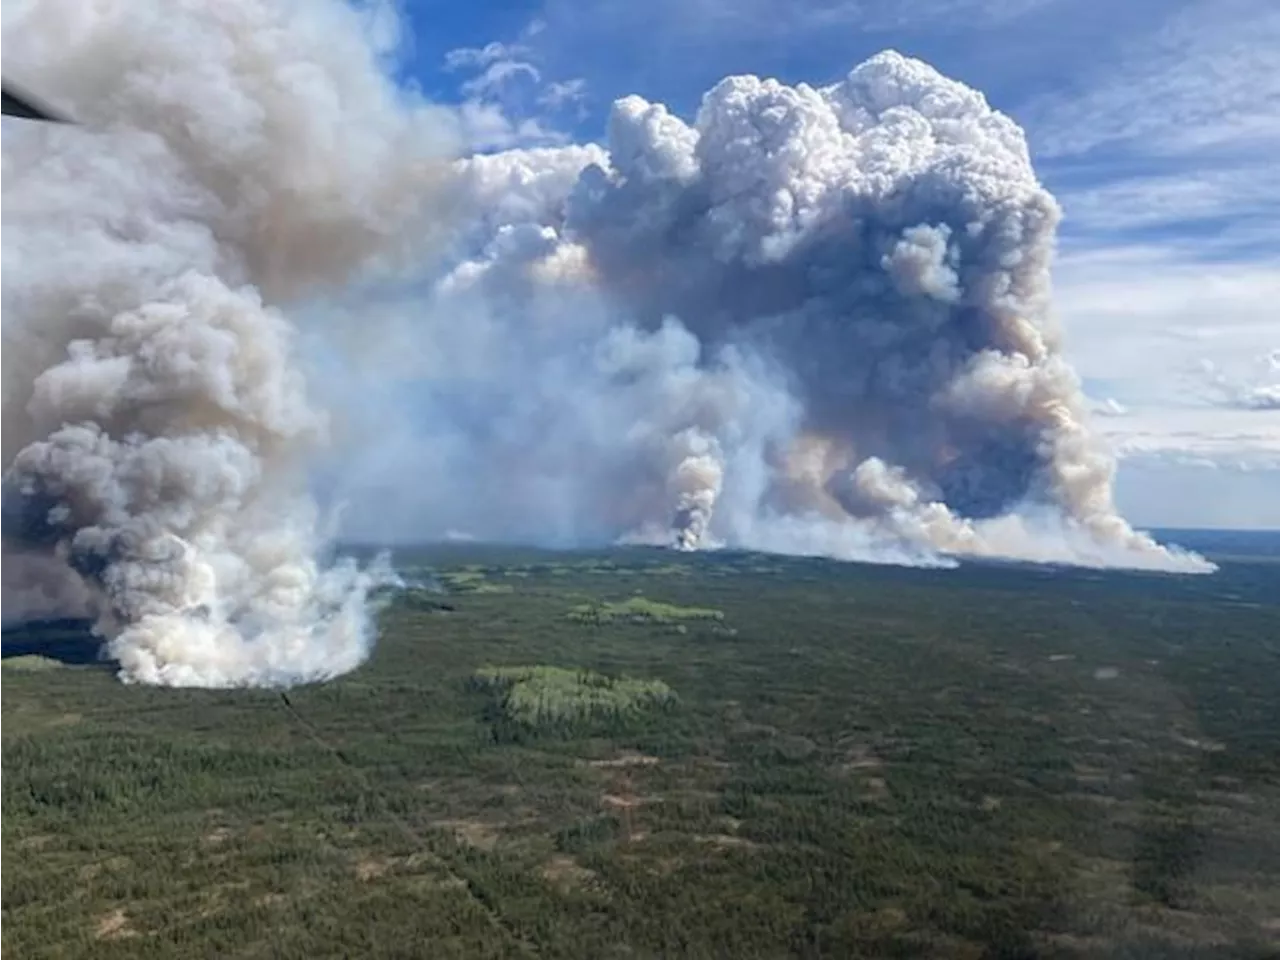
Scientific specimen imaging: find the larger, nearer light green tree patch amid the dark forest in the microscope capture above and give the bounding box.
[474,667,676,727]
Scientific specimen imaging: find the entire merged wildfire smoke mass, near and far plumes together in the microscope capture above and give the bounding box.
[0,0,1211,686]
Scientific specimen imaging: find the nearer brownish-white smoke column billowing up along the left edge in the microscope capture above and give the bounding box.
[0,0,458,686]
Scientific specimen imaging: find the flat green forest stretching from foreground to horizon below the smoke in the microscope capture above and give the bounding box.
[0,545,1280,960]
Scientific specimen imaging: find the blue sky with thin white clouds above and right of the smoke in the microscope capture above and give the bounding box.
[391,0,1280,526]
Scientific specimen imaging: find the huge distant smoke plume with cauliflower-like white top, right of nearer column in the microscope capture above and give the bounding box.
[327,52,1211,571]
